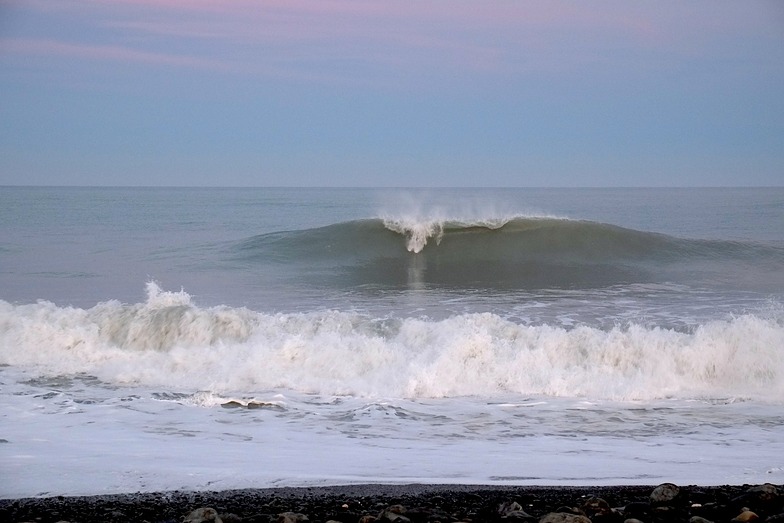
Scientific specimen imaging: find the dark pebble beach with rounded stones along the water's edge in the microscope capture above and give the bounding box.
[0,483,784,523]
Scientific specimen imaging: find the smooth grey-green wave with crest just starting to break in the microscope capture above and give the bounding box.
[232,217,784,288]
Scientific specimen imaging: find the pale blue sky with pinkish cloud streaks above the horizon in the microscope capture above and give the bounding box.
[0,0,784,187]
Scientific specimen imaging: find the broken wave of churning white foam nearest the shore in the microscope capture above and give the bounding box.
[0,285,784,404]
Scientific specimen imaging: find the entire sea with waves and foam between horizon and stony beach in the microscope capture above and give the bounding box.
[0,187,784,498]
